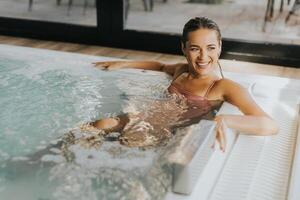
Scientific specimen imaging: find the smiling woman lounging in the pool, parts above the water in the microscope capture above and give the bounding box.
[92,17,278,151]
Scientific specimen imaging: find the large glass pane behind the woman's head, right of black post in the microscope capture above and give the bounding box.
[124,0,300,45]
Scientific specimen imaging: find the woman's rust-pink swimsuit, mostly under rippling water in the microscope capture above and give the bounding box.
[99,74,220,147]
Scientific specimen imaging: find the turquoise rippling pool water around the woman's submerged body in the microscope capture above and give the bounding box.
[0,45,170,200]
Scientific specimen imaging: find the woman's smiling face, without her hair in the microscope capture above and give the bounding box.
[182,29,221,76]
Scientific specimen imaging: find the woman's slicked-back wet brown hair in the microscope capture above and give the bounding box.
[181,17,222,47]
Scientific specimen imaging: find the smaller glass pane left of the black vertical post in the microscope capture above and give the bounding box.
[0,0,97,26]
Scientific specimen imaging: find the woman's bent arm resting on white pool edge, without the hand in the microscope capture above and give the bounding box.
[215,79,279,135]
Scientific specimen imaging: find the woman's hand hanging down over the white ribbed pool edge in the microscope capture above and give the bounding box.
[214,115,227,152]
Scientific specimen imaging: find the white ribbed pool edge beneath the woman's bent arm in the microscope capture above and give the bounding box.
[166,73,300,200]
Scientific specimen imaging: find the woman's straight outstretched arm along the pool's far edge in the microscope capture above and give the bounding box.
[93,61,186,76]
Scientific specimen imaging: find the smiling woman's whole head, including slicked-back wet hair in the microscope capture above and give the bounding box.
[181,18,222,79]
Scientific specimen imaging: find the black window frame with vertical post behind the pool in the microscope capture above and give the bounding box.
[0,0,300,68]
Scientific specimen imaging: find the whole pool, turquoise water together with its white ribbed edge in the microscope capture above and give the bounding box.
[0,45,300,200]
